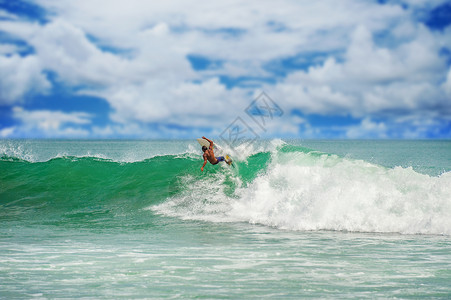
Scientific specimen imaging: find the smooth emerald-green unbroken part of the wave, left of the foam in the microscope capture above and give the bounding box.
[0,152,278,226]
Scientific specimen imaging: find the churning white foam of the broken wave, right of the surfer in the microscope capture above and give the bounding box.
[152,152,451,235]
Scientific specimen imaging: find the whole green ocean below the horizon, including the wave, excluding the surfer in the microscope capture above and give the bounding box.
[0,139,451,299]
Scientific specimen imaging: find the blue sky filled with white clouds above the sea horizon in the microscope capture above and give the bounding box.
[0,0,451,139]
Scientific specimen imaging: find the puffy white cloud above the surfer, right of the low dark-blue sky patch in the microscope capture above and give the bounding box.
[103,78,248,126]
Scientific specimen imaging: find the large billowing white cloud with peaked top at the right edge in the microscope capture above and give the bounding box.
[273,21,450,117]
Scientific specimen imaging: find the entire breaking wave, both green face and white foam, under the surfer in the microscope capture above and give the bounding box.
[0,142,451,235]
